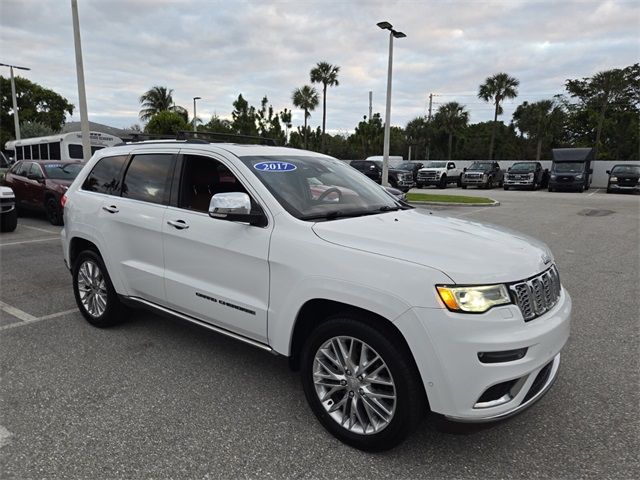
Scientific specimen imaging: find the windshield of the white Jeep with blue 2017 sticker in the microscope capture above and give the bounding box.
[240,155,405,220]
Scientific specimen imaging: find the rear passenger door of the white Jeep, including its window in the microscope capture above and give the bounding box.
[97,150,176,305]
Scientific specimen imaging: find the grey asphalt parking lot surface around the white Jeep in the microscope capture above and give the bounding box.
[0,188,640,479]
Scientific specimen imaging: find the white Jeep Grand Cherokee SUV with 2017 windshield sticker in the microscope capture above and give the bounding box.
[62,140,571,451]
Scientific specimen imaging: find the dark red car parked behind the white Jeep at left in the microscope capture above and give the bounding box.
[4,160,83,225]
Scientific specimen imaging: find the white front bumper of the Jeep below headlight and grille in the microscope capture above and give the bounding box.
[394,289,571,422]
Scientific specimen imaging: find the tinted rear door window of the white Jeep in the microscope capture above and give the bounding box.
[122,154,173,205]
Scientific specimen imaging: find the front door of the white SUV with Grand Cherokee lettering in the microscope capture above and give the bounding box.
[162,154,273,343]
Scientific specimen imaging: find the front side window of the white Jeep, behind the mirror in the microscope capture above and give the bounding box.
[178,155,248,212]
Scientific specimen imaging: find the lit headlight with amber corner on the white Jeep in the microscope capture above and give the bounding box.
[436,285,511,313]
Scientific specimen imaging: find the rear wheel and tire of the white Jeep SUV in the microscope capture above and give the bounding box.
[72,250,128,328]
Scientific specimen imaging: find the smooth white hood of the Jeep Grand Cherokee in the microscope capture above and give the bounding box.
[313,209,553,284]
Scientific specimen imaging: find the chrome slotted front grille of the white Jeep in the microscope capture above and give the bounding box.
[509,265,560,322]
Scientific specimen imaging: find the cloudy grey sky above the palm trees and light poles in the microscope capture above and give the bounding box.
[0,0,640,132]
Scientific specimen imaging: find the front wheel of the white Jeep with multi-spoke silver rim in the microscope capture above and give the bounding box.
[301,313,427,452]
